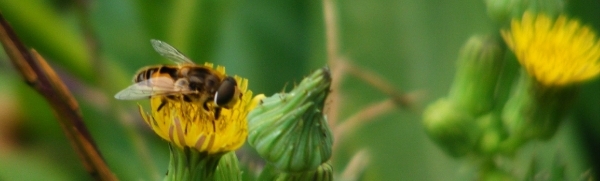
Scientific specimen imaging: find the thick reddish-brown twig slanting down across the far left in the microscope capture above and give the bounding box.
[0,14,117,180]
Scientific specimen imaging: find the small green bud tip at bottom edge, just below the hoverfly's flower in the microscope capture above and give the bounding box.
[215,151,242,181]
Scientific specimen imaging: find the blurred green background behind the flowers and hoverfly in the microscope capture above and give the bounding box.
[0,0,600,180]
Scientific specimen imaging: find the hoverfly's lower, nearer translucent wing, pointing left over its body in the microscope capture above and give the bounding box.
[115,77,191,100]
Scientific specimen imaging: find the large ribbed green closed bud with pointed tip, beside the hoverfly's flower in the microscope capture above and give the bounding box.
[248,68,333,172]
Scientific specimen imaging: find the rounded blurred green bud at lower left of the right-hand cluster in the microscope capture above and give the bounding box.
[423,99,480,157]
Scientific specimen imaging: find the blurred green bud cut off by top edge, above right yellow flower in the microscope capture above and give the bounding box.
[485,0,565,24]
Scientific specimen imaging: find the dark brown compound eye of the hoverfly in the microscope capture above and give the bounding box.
[215,76,241,108]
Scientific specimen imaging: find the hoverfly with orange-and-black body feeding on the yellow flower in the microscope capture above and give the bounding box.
[115,40,242,117]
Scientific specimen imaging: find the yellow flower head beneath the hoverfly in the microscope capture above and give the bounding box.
[139,64,256,154]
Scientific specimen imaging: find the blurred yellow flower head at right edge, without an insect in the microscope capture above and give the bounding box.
[501,12,600,86]
